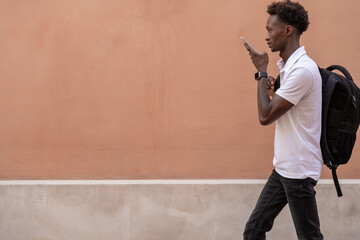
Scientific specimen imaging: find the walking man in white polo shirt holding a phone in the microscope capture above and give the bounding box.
[244,0,323,240]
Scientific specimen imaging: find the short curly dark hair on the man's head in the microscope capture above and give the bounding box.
[267,0,310,34]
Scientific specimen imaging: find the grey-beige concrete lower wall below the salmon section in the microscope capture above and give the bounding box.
[0,183,360,240]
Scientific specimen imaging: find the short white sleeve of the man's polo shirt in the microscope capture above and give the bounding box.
[276,68,313,105]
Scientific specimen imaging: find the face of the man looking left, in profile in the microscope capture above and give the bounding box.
[265,15,287,52]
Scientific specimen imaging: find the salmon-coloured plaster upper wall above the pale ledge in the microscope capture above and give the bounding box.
[0,0,360,179]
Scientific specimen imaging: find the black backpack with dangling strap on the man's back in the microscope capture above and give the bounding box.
[275,65,360,197]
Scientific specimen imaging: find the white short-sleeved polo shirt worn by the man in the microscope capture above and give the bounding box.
[273,47,323,180]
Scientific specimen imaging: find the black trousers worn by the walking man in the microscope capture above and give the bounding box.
[244,170,323,240]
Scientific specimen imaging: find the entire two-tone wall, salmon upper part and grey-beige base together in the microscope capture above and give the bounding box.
[0,0,360,240]
